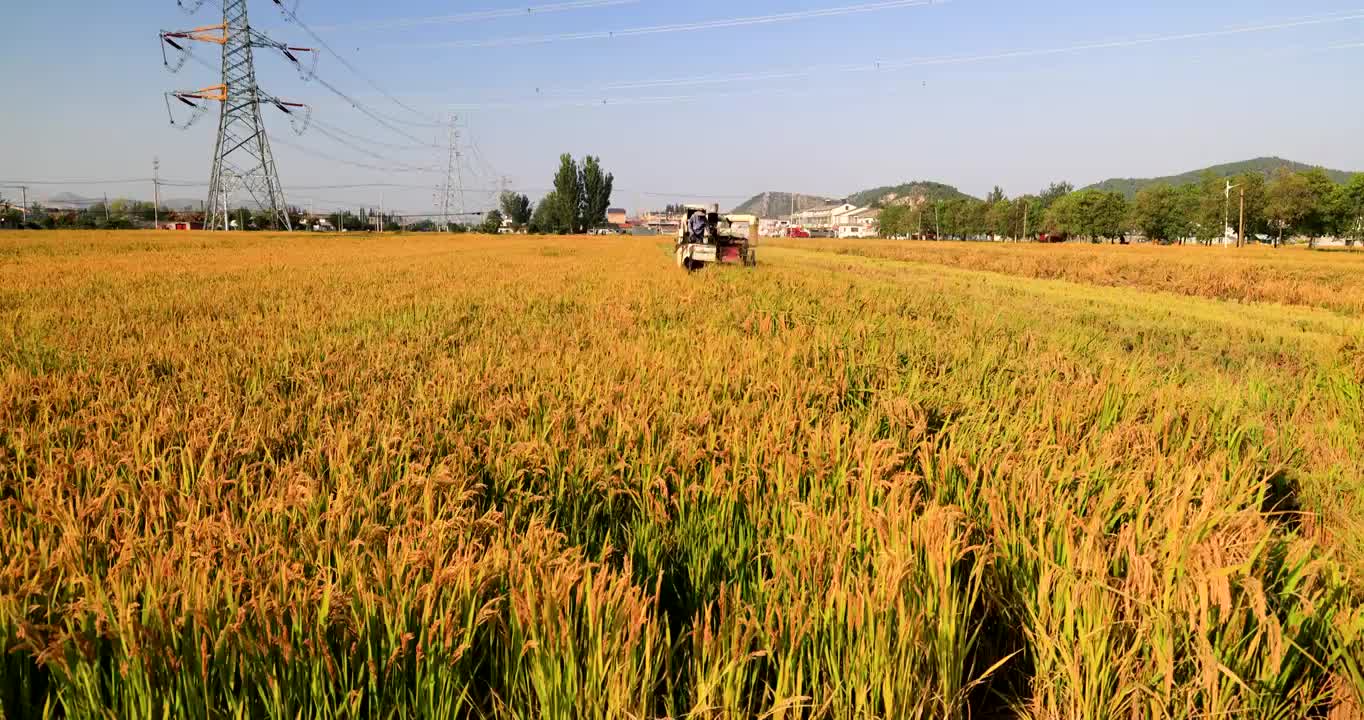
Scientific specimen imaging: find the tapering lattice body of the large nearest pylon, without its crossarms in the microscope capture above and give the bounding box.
[205,0,293,230]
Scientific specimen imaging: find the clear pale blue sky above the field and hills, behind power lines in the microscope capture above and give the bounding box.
[0,0,1364,211]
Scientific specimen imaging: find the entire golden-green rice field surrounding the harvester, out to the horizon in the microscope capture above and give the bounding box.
[0,232,1364,720]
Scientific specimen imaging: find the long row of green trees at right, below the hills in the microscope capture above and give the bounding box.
[880,168,1364,245]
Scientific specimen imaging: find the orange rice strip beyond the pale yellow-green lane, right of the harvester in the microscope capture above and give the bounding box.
[767,240,1364,316]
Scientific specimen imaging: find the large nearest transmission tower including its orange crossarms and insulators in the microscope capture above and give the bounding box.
[161,0,318,230]
